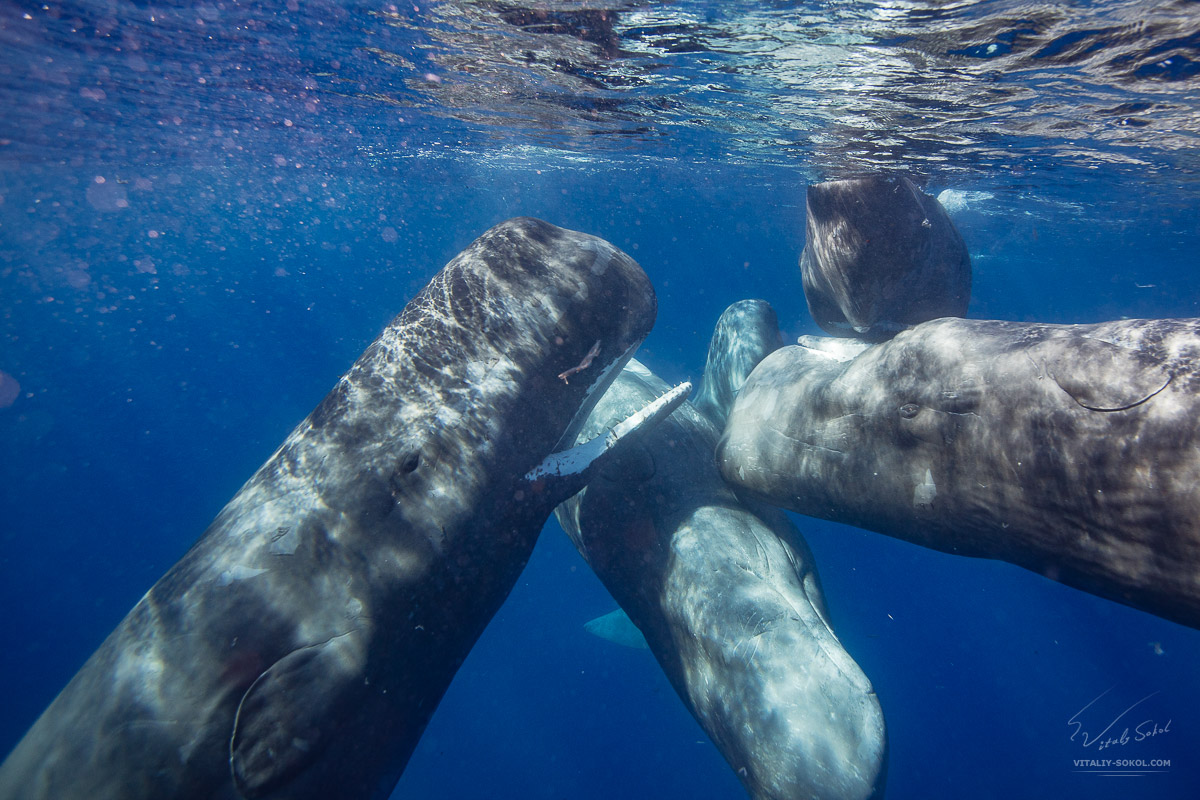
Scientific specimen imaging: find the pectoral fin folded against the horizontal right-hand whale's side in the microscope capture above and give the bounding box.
[1032,337,1171,411]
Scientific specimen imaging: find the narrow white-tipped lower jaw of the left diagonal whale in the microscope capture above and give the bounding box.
[524,381,691,496]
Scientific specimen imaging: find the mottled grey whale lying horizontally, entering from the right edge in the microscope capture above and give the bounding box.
[718,319,1200,627]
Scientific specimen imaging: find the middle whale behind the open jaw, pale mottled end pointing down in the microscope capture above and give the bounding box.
[556,301,887,800]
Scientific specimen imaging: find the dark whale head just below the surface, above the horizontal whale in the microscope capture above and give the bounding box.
[800,175,971,341]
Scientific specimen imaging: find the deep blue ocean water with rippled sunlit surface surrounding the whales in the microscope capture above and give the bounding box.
[0,0,1200,800]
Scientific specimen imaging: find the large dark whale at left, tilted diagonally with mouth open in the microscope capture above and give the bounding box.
[0,218,683,800]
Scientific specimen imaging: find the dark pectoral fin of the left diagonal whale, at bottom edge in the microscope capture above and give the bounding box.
[229,632,360,798]
